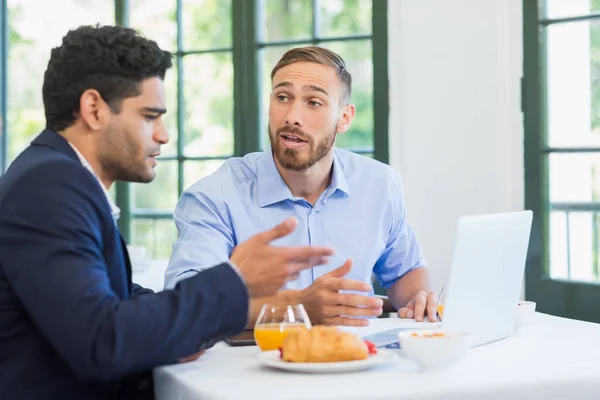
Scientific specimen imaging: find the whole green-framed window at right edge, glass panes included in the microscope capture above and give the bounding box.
[523,0,600,321]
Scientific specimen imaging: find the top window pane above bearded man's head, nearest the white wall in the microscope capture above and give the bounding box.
[319,0,373,37]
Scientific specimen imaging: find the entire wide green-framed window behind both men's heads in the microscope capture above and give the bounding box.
[0,0,388,258]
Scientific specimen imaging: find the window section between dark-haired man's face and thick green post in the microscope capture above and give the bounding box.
[126,0,234,258]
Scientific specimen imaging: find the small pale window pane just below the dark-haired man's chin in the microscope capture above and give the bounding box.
[132,160,179,212]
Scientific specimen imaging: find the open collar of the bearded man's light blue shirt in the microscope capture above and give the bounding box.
[258,149,350,207]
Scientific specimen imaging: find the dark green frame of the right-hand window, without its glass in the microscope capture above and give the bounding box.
[522,0,600,322]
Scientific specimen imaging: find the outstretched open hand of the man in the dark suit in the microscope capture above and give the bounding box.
[230,218,333,298]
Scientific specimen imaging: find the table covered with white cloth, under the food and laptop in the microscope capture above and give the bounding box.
[154,313,600,400]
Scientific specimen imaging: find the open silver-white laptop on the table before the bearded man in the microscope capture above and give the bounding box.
[365,210,533,348]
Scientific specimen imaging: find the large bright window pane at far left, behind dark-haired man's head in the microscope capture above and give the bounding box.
[6,0,115,164]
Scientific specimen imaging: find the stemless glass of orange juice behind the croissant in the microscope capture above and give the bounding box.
[254,304,312,351]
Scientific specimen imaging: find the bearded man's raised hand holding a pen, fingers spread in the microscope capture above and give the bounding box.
[300,260,383,326]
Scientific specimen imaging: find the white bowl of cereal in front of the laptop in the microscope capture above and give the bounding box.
[398,329,471,371]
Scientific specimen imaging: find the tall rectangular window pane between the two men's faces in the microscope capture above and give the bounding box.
[183,53,233,156]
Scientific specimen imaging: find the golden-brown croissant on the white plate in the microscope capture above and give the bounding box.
[281,326,369,362]
